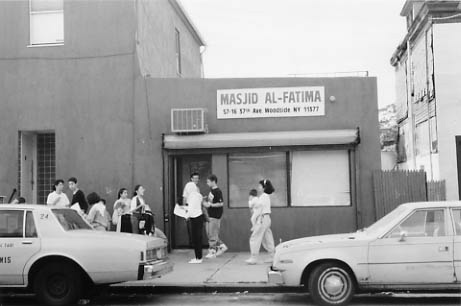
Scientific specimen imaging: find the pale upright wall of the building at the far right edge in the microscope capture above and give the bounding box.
[433,23,461,200]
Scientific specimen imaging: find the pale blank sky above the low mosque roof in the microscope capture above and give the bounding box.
[181,0,406,107]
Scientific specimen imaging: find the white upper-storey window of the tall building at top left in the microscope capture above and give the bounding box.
[29,0,64,45]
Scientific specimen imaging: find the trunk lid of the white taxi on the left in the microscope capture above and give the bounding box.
[63,230,167,249]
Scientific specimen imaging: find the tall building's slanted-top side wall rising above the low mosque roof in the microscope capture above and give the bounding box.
[137,0,201,78]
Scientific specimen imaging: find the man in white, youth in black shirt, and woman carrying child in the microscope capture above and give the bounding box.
[182,172,275,264]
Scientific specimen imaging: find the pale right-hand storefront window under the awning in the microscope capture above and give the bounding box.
[291,150,351,206]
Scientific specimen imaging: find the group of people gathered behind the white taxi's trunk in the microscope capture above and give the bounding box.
[46,177,162,239]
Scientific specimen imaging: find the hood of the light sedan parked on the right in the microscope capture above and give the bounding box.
[277,232,370,250]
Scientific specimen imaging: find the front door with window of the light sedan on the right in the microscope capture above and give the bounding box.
[368,208,454,287]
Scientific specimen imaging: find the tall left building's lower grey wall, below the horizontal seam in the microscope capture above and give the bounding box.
[0,55,133,208]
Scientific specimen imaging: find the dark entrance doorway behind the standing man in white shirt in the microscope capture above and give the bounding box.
[170,154,211,249]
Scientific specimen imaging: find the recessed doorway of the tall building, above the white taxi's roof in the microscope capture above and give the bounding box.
[18,131,56,204]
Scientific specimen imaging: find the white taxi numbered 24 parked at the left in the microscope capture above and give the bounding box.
[0,204,173,305]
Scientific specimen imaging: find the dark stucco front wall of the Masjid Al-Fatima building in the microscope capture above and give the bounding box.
[135,78,381,241]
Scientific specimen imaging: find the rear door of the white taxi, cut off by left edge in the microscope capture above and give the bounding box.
[0,209,40,285]
